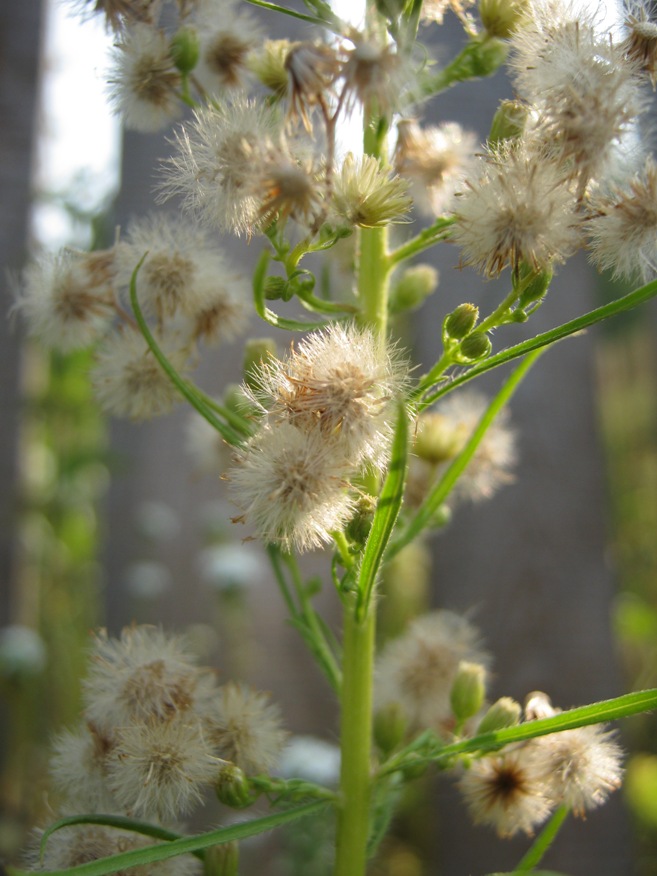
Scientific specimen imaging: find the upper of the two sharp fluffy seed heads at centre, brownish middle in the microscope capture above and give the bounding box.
[247,323,408,468]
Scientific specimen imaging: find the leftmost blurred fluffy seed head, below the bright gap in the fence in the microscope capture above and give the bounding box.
[14,250,116,350]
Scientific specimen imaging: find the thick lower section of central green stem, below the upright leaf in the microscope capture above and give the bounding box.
[335,600,376,876]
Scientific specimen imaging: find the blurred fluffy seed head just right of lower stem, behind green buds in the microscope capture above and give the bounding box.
[375,611,490,732]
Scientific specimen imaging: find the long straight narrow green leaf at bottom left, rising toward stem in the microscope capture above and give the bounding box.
[7,800,329,876]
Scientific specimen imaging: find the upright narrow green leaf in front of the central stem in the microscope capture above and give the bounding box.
[357,403,408,617]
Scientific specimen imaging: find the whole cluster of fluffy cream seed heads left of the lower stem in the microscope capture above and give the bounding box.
[40,626,287,873]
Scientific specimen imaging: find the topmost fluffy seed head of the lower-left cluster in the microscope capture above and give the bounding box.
[84,626,214,738]
